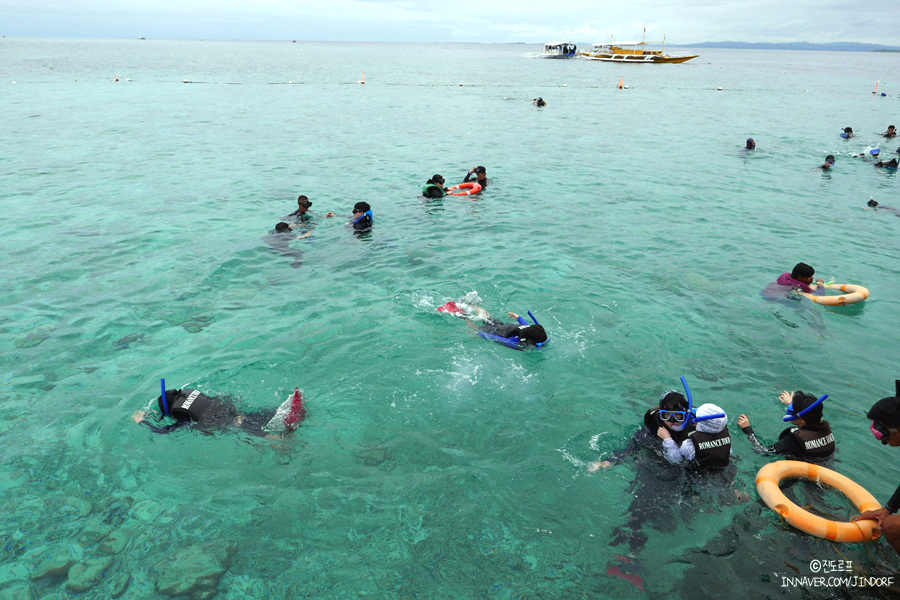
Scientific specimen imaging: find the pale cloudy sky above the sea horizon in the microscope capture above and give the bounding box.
[0,0,900,46]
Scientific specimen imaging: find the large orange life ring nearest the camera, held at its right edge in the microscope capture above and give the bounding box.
[756,460,881,542]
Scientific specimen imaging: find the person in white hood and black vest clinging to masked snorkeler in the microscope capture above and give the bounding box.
[657,403,731,469]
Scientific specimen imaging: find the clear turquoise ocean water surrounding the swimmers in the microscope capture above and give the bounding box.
[0,38,900,599]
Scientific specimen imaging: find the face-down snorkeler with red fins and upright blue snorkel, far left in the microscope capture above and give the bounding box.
[132,381,306,436]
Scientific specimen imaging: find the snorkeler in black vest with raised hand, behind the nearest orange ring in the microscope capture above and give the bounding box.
[738,390,835,460]
